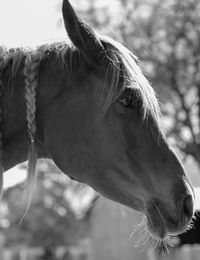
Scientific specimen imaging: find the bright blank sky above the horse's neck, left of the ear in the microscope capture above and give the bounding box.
[0,0,66,46]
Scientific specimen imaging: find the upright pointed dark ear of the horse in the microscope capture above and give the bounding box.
[62,0,104,59]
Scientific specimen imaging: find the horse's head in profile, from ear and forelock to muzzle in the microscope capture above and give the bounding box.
[45,0,194,248]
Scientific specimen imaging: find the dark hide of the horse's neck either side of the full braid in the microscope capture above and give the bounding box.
[0,52,66,170]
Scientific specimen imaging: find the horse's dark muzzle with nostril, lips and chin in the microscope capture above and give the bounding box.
[146,194,194,240]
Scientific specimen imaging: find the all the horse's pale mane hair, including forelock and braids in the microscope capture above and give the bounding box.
[0,36,160,211]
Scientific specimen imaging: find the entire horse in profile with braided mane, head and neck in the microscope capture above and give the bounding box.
[0,0,194,253]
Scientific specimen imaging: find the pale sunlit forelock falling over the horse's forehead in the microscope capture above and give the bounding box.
[101,36,160,124]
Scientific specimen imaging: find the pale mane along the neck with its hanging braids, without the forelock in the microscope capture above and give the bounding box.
[0,42,72,205]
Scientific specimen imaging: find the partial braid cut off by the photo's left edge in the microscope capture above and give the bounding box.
[0,57,4,199]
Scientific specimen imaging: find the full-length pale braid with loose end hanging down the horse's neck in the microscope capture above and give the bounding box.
[24,51,40,214]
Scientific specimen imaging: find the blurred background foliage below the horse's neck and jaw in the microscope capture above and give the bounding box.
[1,162,96,247]
